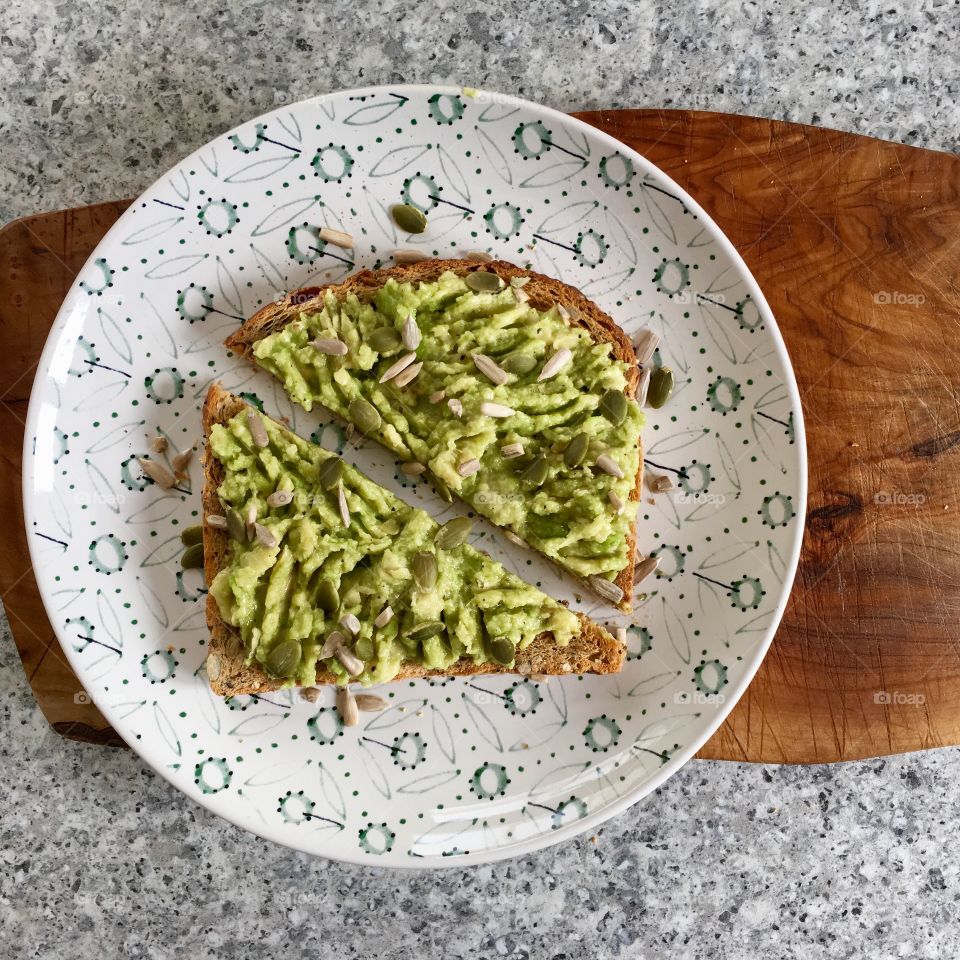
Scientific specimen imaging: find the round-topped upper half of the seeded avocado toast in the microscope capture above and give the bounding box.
[226,260,643,609]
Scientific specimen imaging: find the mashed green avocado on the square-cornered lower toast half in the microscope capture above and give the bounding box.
[210,413,580,685]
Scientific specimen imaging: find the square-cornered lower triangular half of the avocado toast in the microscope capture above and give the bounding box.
[203,385,624,696]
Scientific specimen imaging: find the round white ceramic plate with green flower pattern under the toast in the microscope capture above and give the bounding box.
[24,86,806,866]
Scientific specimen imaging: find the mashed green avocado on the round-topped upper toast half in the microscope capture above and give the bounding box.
[254,272,643,580]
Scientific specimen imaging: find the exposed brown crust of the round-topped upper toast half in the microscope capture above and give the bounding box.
[224,260,643,610]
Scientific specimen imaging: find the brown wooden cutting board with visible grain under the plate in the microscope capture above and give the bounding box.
[0,110,960,763]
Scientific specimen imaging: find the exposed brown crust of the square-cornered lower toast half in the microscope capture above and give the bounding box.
[203,384,626,697]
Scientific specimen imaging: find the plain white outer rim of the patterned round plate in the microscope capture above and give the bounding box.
[21,83,808,870]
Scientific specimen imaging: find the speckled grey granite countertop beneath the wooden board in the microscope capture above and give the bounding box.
[0,0,960,960]
